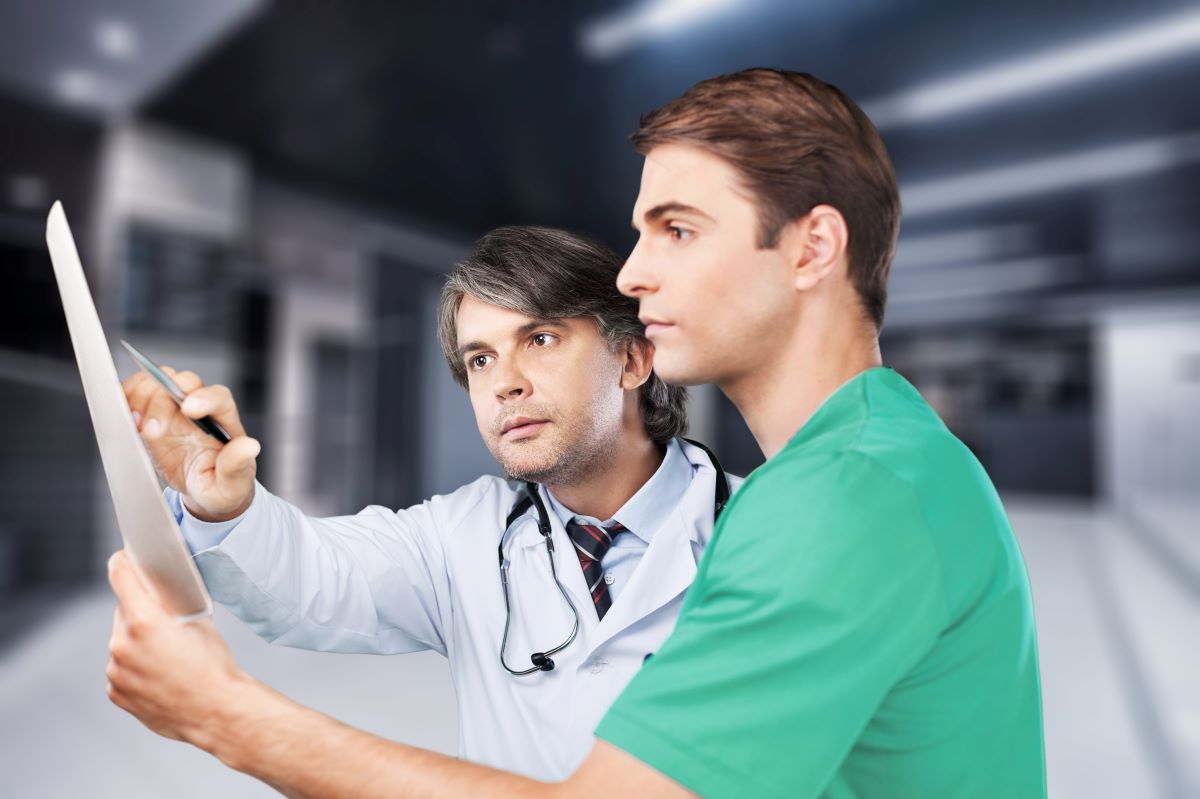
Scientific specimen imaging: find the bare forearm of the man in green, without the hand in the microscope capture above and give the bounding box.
[202,678,558,799]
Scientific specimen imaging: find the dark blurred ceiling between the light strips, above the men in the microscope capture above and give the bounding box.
[146,0,1200,248]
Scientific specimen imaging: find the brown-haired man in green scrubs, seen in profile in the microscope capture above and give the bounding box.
[113,70,1045,799]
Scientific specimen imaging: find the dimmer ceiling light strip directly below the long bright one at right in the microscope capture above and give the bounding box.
[900,133,1200,218]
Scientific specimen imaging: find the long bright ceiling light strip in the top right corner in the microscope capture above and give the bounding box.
[863,11,1200,130]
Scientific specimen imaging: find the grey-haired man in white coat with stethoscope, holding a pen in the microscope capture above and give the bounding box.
[119,227,728,780]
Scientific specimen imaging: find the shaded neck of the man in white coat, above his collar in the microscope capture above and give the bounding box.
[546,421,664,521]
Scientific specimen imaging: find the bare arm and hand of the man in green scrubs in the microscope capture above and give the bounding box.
[106,552,688,799]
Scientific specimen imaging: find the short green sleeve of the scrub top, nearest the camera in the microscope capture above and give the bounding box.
[596,452,947,797]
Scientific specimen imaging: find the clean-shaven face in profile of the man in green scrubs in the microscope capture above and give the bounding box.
[617,144,796,385]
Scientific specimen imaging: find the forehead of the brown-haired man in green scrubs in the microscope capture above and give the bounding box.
[634,144,750,222]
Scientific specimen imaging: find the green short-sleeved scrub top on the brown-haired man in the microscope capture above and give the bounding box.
[596,367,1045,799]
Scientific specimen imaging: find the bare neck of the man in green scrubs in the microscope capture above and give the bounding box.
[719,298,883,458]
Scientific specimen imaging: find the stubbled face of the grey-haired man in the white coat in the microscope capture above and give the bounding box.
[457,295,625,485]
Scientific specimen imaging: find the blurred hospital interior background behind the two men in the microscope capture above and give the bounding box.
[0,0,1200,799]
